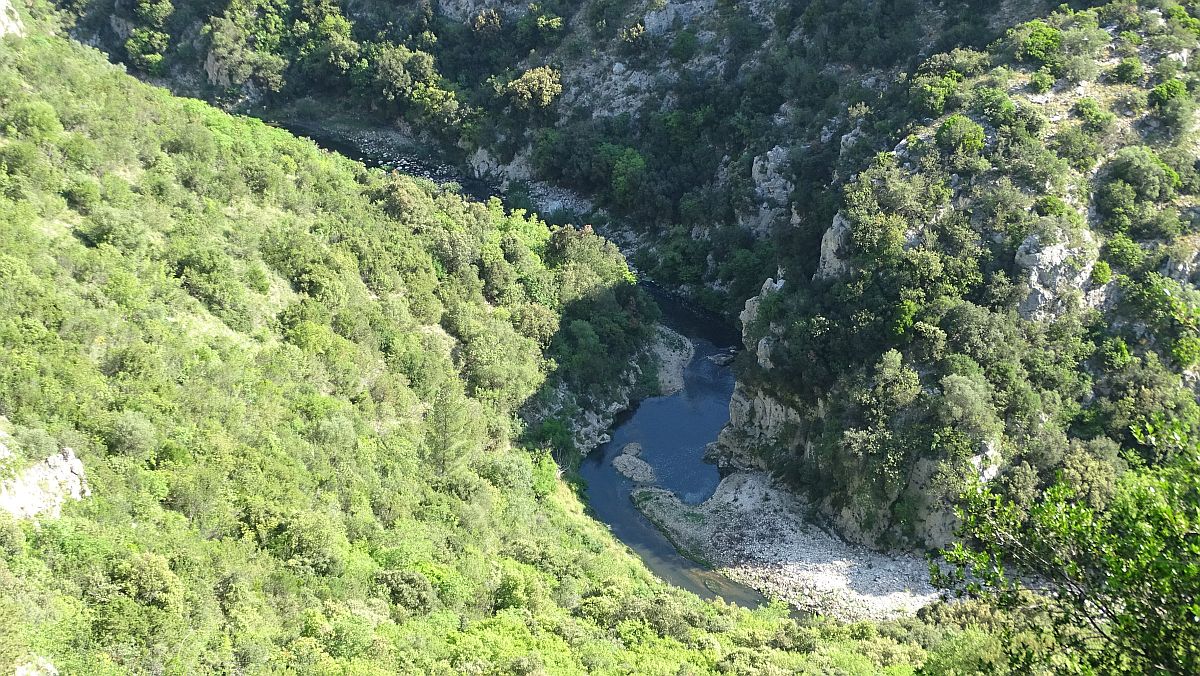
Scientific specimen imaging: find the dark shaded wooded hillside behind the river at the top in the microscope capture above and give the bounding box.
[46,0,1080,313]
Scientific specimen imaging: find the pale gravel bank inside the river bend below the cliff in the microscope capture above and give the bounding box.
[634,472,937,621]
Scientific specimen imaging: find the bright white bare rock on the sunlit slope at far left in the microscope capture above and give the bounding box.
[0,431,91,519]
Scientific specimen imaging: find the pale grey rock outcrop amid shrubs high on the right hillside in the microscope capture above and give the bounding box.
[1016,231,1103,321]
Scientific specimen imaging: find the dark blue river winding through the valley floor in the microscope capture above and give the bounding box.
[280,124,767,608]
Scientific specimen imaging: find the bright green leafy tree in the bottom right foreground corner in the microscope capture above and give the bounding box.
[935,445,1200,674]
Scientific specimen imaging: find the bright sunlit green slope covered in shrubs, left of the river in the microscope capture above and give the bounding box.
[0,25,988,674]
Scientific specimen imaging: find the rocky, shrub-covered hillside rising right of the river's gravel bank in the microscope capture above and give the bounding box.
[724,4,1200,545]
